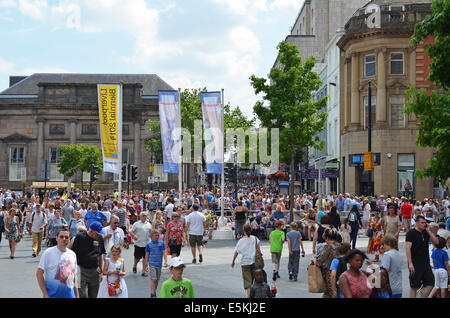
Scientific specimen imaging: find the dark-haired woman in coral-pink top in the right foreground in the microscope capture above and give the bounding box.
[339,249,372,298]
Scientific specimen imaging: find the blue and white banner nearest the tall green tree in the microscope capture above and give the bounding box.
[200,92,224,174]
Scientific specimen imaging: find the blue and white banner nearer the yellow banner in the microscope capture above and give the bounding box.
[158,91,181,174]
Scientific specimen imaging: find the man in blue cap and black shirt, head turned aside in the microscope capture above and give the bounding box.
[72,221,106,298]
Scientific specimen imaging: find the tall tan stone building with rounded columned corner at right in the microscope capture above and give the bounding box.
[337,0,433,199]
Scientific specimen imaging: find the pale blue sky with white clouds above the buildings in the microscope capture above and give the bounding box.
[0,0,303,116]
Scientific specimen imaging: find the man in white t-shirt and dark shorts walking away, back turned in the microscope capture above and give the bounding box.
[186,204,206,264]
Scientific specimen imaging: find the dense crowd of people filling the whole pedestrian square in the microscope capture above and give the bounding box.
[0,186,450,298]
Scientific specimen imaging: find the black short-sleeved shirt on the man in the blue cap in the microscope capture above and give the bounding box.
[72,232,106,268]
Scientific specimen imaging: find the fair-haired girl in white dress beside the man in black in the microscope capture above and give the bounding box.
[98,244,128,298]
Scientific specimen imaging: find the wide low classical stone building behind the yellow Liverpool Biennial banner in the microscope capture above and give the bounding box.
[0,74,176,190]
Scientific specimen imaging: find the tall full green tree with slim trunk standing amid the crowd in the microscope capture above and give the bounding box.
[250,42,328,222]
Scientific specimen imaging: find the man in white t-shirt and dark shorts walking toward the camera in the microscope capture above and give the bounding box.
[130,211,152,276]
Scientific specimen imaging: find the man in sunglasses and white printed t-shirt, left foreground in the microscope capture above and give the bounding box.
[36,226,79,298]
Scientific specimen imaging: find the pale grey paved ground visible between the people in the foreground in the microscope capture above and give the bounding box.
[0,233,409,298]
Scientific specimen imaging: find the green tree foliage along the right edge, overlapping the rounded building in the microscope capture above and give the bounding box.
[405,0,450,185]
